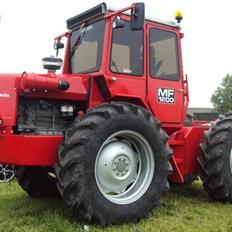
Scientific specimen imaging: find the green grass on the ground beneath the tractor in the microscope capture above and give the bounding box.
[0,182,232,232]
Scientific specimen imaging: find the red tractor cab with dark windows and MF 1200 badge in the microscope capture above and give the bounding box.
[55,3,188,132]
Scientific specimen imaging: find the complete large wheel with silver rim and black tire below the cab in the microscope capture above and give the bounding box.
[55,103,171,225]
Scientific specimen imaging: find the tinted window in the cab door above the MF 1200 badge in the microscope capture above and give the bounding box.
[150,28,179,80]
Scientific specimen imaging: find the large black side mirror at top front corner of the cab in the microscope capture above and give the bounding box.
[131,2,145,31]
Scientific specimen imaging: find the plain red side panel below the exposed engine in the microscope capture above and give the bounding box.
[0,135,63,166]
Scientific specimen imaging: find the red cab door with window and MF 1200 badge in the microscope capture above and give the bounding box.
[147,24,184,123]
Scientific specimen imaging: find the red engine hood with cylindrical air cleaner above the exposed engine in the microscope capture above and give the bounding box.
[0,73,88,126]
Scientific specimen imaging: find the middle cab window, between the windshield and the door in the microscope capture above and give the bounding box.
[110,21,143,76]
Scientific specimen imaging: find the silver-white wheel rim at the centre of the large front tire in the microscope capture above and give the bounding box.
[95,130,155,205]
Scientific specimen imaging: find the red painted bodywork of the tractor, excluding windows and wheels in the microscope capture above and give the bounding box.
[0,4,208,183]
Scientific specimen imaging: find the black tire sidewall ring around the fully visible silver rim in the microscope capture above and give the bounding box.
[77,110,167,221]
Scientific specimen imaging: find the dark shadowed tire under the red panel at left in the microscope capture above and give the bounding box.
[15,166,60,198]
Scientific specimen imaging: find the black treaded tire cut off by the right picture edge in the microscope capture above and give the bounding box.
[198,114,232,202]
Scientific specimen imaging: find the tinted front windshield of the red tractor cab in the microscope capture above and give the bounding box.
[70,20,105,73]
